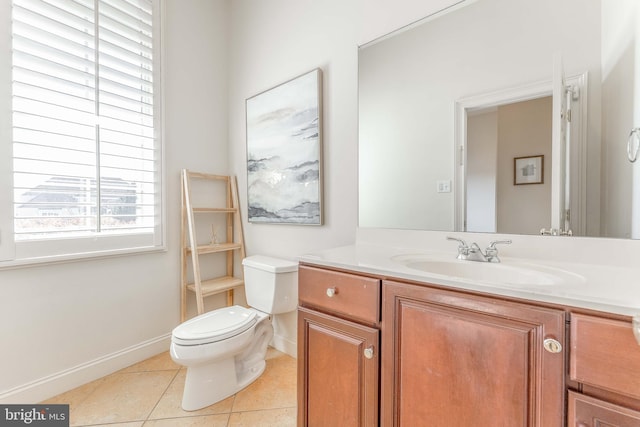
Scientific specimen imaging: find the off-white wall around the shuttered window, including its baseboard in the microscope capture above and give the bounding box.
[0,0,228,403]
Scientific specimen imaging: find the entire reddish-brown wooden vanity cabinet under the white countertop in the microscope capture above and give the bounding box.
[298,263,640,427]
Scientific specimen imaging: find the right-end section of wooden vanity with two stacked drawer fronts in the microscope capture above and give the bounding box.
[568,313,640,427]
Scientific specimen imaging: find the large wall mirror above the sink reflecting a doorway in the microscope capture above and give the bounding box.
[359,0,640,238]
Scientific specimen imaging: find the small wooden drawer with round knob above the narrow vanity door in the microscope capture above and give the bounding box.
[298,266,380,325]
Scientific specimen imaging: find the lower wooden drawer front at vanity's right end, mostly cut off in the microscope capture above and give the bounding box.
[567,391,640,427]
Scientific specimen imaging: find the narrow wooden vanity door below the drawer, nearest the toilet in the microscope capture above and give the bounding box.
[298,308,380,427]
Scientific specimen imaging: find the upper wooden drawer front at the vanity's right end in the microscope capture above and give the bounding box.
[570,314,640,399]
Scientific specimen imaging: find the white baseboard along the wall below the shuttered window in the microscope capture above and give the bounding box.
[0,333,171,404]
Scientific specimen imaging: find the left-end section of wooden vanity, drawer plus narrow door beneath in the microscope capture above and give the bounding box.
[298,265,381,427]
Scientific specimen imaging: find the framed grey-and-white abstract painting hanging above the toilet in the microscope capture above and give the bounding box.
[246,68,323,225]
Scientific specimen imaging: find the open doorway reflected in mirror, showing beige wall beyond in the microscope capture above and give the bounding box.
[464,96,551,234]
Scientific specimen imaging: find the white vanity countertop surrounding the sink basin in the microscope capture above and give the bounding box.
[299,243,640,316]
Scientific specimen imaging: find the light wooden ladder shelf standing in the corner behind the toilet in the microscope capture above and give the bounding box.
[180,169,250,322]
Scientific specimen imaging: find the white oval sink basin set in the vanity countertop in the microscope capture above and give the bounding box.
[395,257,583,286]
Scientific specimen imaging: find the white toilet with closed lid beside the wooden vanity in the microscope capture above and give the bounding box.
[170,255,298,411]
